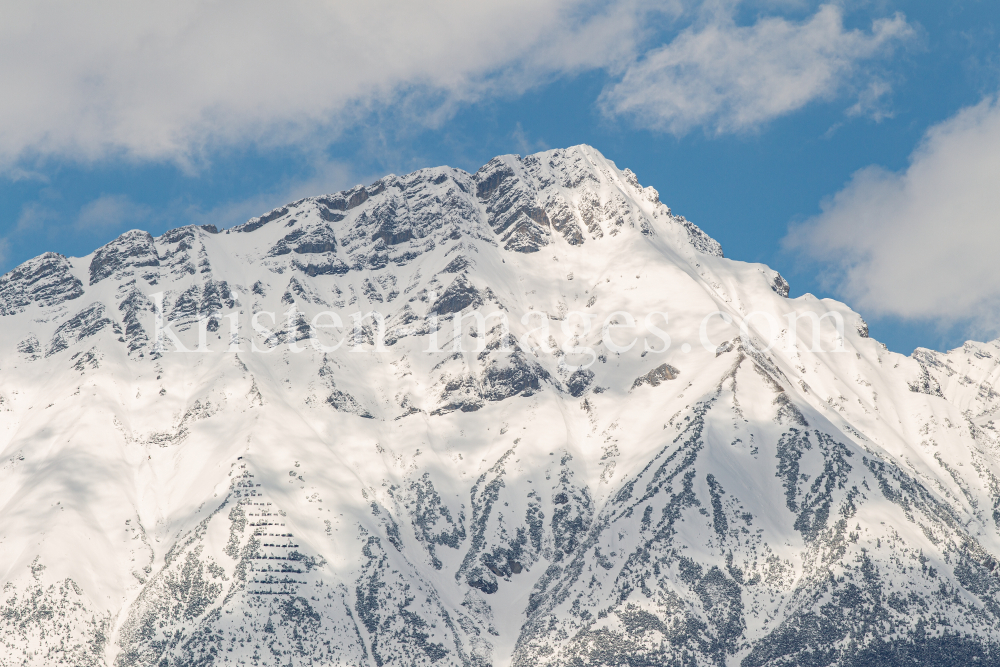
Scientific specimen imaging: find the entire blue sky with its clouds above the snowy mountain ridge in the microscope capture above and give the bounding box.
[0,0,1000,353]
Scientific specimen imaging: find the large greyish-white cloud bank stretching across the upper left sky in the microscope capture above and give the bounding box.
[0,0,642,170]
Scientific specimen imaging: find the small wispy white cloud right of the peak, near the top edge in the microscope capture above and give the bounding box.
[601,5,913,134]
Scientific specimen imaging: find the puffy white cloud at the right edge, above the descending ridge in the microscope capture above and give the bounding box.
[786,98,1000,335]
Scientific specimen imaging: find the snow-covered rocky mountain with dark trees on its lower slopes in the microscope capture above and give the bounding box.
[0,146,1000,667]
